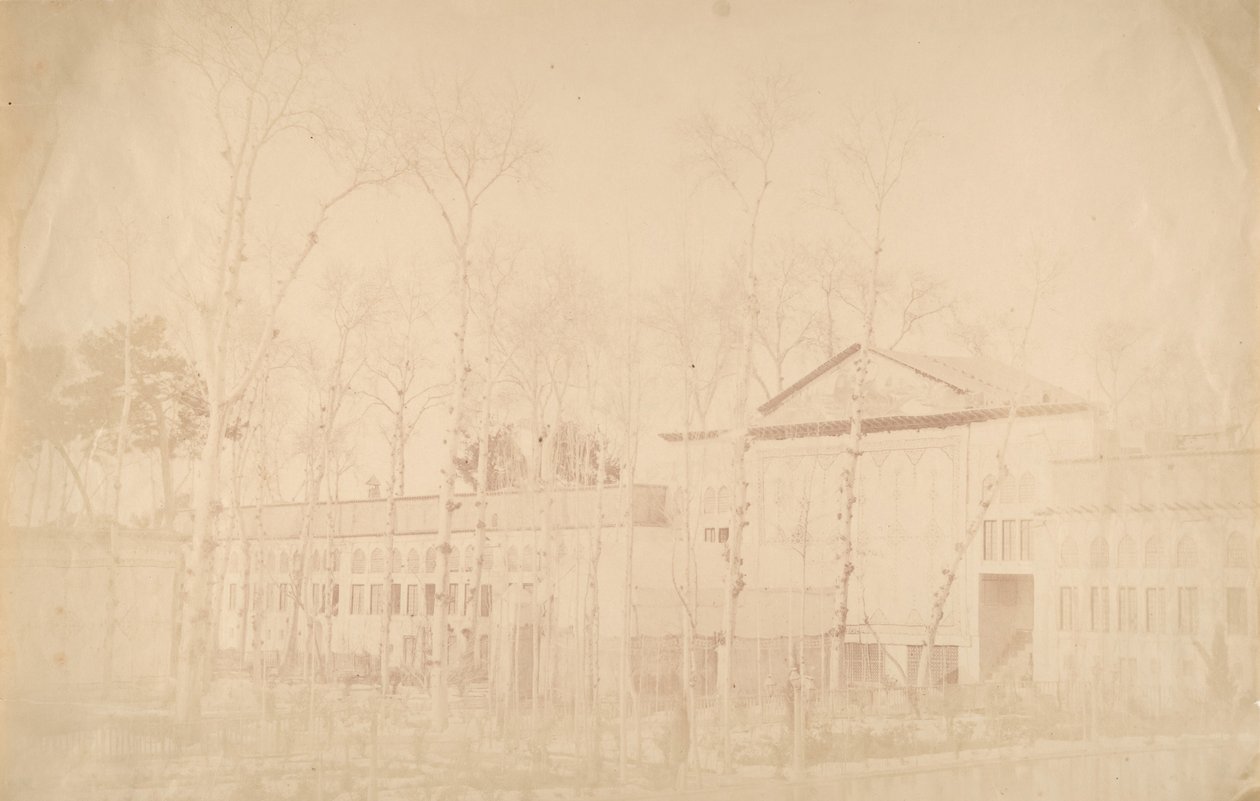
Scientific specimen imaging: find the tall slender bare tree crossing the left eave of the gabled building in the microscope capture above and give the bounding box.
[692,74,793,772]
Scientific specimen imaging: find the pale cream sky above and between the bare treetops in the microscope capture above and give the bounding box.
[9,0,1257,501]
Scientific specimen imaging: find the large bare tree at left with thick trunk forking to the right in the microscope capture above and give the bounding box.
[161,1,394,720]
